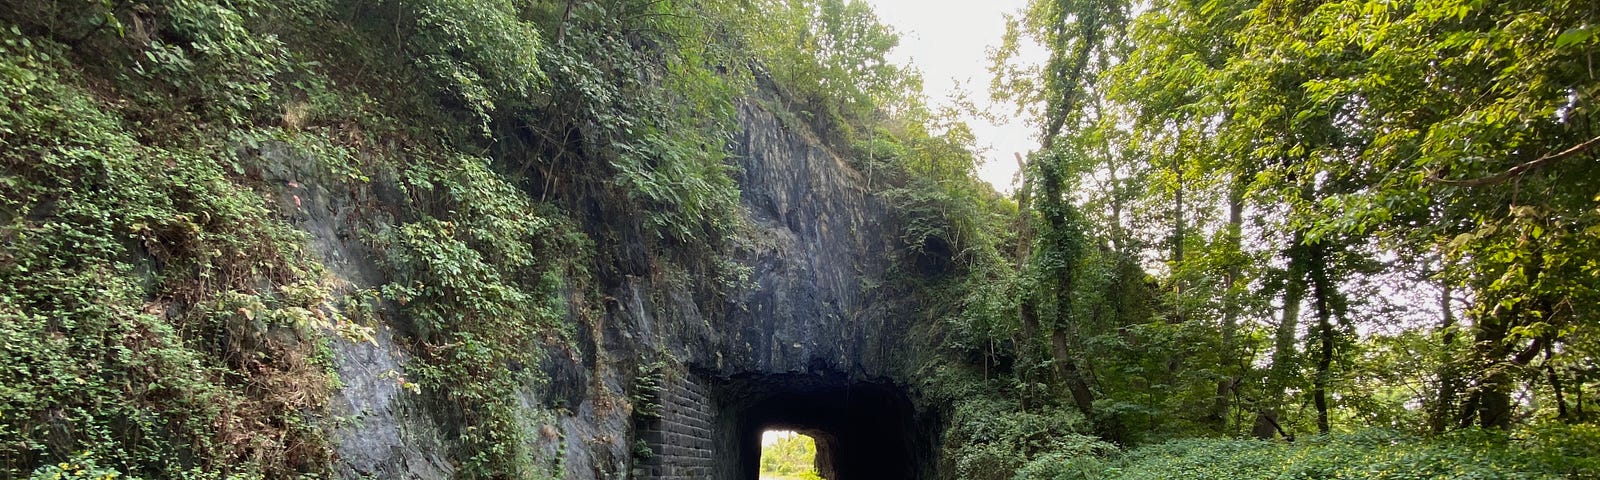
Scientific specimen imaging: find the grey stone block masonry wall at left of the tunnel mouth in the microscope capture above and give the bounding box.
[638,374,717,480]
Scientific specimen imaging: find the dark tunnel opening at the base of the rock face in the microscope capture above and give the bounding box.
[714,373,939,480]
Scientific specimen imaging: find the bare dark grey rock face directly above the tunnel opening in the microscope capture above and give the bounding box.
[716,102,898,376]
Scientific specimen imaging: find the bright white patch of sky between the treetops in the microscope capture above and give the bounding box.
[862,0,1042,192]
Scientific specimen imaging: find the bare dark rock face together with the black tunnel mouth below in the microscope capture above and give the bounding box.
[707,104,938,480]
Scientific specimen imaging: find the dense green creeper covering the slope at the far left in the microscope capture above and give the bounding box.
[0,20,341,478]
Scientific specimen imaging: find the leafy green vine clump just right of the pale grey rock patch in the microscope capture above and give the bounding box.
[376,155,584,478]
